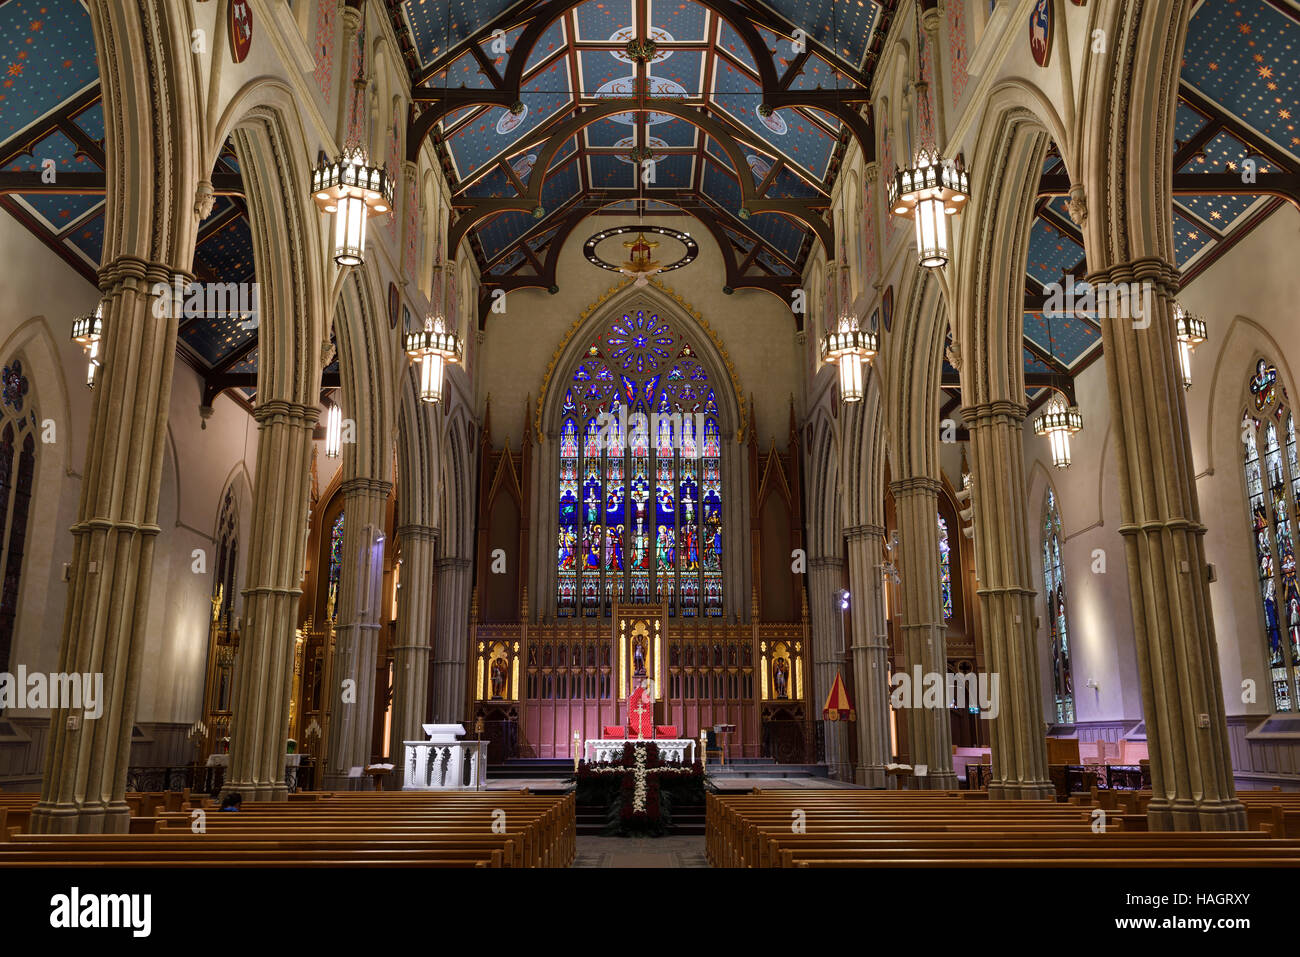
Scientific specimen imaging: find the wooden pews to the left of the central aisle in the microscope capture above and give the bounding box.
[0,791,577,867]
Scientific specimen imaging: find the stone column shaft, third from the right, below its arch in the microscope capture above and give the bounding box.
[889,476,957,791]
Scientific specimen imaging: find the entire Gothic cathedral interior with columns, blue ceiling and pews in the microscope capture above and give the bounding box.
[0,0,1300,920]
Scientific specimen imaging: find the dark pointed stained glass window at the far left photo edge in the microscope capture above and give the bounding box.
[0,359,39,672]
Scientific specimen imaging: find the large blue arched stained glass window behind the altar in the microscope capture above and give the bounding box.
[556,311,723,618]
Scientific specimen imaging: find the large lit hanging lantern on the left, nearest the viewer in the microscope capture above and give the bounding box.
[312,35,393,267]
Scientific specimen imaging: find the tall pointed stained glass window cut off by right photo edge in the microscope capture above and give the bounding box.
[1242,359,1300,711]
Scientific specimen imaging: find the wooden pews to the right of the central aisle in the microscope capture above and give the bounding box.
[706,789,1300,867]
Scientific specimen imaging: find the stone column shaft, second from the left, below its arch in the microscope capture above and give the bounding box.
[225,399,319,801]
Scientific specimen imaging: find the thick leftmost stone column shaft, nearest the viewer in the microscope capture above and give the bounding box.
[31,256,189,833]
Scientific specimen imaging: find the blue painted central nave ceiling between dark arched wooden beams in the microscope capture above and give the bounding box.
[394,0,892,278]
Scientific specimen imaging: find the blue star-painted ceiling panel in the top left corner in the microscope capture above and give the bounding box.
[0,0,99,142]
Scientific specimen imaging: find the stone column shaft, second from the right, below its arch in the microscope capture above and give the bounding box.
[963,400,1056,800]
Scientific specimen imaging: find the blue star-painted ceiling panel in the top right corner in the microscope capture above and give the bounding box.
[1183,0,1300,159]
